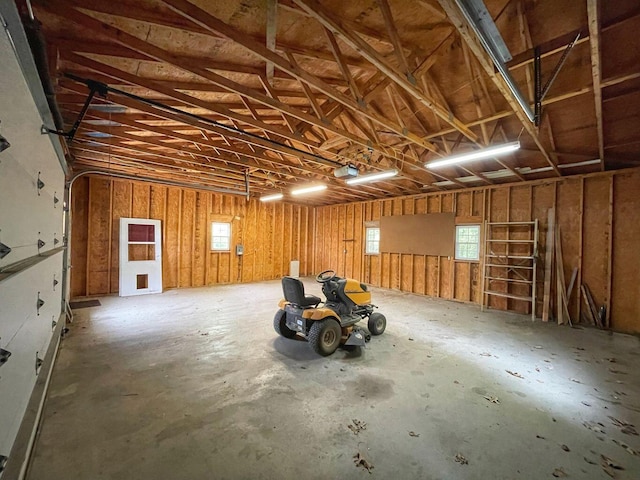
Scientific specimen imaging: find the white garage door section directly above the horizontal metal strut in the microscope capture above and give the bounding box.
[0,154,64,266]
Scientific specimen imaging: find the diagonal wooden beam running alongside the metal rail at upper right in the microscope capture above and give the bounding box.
[438,0,562,176]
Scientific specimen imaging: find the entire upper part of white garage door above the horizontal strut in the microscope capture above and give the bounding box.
[0,26,64,266]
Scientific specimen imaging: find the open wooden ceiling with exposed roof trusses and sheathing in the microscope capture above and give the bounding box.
[23,0,640,205]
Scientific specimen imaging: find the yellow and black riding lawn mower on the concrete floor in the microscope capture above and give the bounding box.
[273,270,387,356]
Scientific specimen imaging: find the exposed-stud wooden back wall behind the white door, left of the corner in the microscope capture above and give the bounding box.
[71,176,313,297]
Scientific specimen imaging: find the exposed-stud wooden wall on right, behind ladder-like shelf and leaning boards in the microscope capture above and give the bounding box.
[313,169,640,333]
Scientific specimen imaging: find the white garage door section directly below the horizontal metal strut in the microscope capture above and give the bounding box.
[0,252,62,360]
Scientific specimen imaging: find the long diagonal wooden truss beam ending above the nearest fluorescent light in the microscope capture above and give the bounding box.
[293,0,477,141]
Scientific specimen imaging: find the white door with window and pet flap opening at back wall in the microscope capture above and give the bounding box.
[120,218,162,297]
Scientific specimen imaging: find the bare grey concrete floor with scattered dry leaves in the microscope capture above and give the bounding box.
[28,278,640,480]
